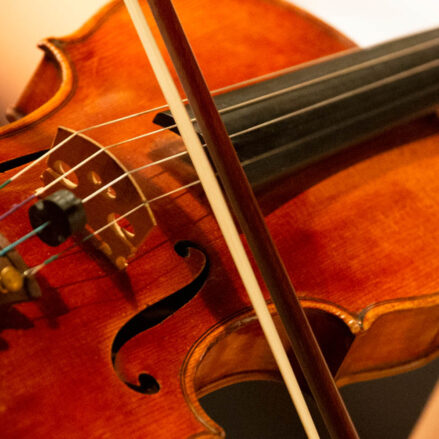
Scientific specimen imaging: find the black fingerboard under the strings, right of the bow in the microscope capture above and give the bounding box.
[155,25,439,186]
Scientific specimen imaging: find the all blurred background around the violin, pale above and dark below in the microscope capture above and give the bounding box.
[0,0,439,439]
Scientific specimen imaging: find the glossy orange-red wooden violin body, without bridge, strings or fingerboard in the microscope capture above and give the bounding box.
[0,0,439,438]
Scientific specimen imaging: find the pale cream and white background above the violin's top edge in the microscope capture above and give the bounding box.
[0,0,439,124]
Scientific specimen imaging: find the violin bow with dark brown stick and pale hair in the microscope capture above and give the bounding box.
[124,0,358,439]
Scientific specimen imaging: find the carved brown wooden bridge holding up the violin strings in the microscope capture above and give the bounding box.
[41,127,156,270]
